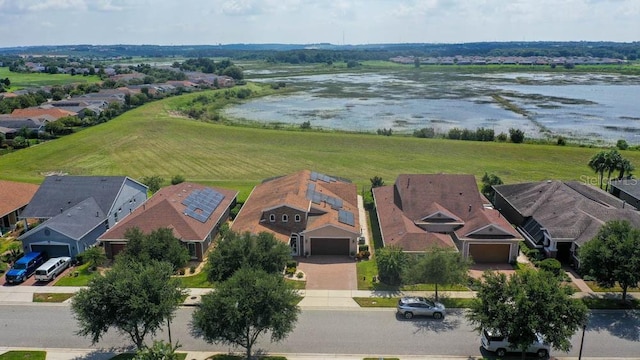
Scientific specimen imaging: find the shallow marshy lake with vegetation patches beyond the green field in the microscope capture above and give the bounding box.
[223,71,640,145]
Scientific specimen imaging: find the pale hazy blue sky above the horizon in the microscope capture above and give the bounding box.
[0,0,640,47]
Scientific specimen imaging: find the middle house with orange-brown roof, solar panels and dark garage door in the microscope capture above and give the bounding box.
[231,170,361,256]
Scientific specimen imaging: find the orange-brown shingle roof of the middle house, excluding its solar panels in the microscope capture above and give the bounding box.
[231,170,360,242]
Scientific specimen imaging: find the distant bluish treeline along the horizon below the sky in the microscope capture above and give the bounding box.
[0,41,640,64]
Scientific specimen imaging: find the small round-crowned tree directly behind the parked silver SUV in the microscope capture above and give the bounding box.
[403,247,471,301]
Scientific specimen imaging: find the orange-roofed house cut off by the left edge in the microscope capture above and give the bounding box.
[0,180,38,236]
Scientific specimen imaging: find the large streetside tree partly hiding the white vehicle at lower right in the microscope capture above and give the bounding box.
[467,270,587,359]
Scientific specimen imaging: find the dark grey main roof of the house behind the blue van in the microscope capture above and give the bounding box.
[20,176,127,219]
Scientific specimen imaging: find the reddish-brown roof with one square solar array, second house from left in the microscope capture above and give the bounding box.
[100,182,238,241]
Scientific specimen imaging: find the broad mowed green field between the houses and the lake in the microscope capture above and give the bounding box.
[0,89,640,199]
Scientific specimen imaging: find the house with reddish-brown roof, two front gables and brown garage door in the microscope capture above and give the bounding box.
[373,174,522,263]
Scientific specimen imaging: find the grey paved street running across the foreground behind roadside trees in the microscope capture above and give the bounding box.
[0,305,640,358]
